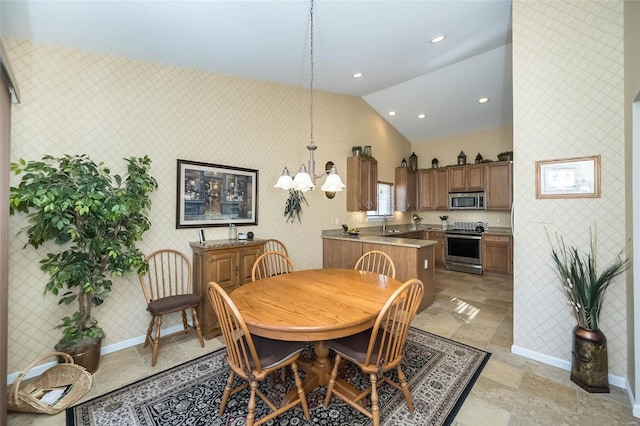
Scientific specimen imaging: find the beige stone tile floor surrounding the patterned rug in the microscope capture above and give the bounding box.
[8,270,640,426]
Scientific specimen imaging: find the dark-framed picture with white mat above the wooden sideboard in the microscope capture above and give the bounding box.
[176,160,258,228]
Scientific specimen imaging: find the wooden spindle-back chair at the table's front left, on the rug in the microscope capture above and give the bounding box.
[207,281,310,426]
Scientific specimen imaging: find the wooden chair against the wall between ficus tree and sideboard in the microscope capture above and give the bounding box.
[138,249,204,367]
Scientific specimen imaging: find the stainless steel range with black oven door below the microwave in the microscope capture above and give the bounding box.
[445,222,489,275]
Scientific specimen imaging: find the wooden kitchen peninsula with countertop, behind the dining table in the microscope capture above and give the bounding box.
[322,227,437,311]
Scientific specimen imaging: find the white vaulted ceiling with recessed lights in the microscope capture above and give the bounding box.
[0,0,512,142]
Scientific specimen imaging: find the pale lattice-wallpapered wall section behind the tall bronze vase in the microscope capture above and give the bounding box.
[513,0,627,377]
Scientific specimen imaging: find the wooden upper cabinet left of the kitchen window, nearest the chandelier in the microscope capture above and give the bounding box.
[347,156,378,212]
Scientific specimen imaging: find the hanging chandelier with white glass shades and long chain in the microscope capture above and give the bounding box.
[274,0,345,198]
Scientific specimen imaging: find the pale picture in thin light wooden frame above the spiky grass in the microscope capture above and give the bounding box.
[536,155,600,198]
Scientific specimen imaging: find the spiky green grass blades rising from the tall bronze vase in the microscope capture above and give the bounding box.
[547,228,630,330]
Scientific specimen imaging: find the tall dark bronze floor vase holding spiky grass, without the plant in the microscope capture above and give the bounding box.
[571,326,609,393]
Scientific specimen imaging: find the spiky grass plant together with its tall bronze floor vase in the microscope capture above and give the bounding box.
[547,229,630,392]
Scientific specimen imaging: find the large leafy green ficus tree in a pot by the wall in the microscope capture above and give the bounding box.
[9,155,158,373]
